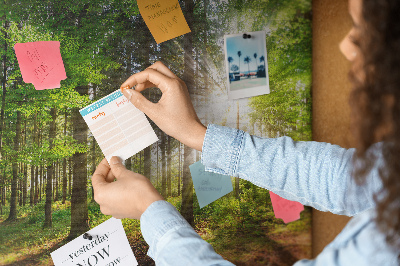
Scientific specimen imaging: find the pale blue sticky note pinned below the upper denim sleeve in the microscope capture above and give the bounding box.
[189,161,233,208]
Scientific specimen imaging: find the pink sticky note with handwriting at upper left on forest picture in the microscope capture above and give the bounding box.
[14,41,67,90]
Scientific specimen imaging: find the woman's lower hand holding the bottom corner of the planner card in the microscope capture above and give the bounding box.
[92,156,163,219]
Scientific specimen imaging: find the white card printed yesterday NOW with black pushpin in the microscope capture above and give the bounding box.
[51,218,138,266]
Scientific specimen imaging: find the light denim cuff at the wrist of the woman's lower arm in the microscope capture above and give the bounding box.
[140,200,192,259]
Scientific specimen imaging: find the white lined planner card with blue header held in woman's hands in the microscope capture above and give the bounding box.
[80,90,158,161]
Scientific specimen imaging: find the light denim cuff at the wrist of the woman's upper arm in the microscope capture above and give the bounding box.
[201,124,244,176]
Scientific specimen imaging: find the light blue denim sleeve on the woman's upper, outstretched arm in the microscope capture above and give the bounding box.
[202,125,381,216]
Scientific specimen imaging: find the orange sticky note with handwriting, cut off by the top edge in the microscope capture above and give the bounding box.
[137,0,190,43]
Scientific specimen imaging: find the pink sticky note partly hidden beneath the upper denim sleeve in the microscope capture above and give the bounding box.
[269,191,304,224]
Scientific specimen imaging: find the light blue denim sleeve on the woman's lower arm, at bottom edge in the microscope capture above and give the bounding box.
[140,200,233,265]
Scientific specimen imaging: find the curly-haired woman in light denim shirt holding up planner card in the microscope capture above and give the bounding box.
[92,0,400,265]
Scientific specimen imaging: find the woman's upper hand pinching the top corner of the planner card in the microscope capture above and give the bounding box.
[121,62,206,151]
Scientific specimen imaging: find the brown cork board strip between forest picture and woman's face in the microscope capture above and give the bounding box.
[312,0,354,257]
